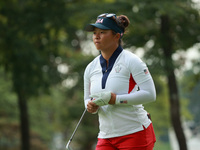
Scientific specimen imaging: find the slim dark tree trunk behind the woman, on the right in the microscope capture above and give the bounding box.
[161,15,187,150]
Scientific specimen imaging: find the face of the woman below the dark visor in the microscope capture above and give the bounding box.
[93,28,119,51]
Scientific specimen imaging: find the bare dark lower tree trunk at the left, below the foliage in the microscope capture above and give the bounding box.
[17,90,30,150]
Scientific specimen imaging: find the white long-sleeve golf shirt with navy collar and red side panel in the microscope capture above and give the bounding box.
[84,46,156,138]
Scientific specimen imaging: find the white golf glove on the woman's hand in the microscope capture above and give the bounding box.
[90,92,111,106]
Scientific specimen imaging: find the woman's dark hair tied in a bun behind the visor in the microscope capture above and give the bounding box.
[113,15,130,46]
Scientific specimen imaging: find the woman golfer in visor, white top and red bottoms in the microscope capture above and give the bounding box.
[84,13,156,150]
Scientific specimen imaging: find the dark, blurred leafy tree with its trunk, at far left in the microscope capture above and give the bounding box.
[0,0,67,150]
